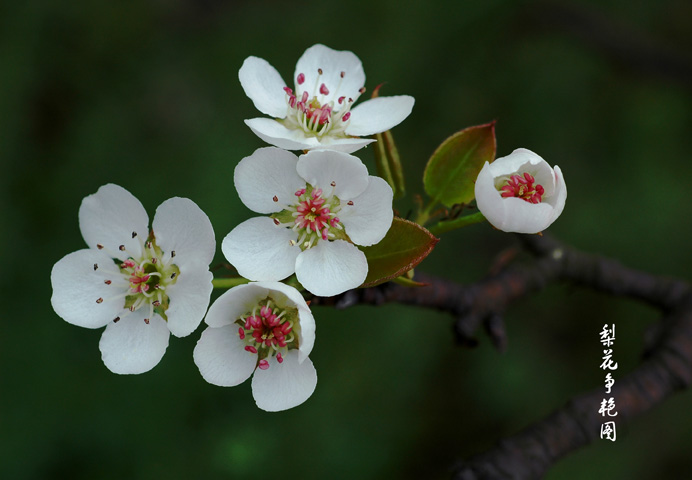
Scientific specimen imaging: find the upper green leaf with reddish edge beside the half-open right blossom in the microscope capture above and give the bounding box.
[423,122,496,207]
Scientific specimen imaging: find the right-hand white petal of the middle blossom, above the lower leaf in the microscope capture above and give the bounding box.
[339,176,394,246]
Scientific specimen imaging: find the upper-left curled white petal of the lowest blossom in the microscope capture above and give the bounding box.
[204,282,270,328]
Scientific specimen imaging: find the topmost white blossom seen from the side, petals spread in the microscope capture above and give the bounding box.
[238,44,414,153]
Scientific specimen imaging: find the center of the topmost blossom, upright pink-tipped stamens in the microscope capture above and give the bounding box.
[283,68,365,137]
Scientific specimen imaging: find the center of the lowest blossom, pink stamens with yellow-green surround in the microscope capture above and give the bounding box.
[235,297,300,370]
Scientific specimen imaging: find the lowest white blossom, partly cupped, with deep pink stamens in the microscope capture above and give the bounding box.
[194,282,317,412]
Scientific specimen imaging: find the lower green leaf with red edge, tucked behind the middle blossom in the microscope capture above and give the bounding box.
[361,217,439,287]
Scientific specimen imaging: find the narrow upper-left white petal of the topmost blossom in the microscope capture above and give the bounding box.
[238,57,288,118]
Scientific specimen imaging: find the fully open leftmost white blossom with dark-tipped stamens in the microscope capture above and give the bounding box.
[51,184,216,374]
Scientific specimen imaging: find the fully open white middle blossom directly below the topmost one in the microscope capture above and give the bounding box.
[221,147,393,297]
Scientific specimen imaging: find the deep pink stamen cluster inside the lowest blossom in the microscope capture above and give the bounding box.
[238,303,294,370]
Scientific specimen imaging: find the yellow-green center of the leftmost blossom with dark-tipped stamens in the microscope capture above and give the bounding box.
[94,232,180,324]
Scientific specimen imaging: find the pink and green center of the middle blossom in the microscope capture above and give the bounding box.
[272,182,346,250]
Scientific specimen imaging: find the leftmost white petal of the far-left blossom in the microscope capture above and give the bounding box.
[50,249,127,328]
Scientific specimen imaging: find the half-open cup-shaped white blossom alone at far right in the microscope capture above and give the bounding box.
[475,148,567,233]
